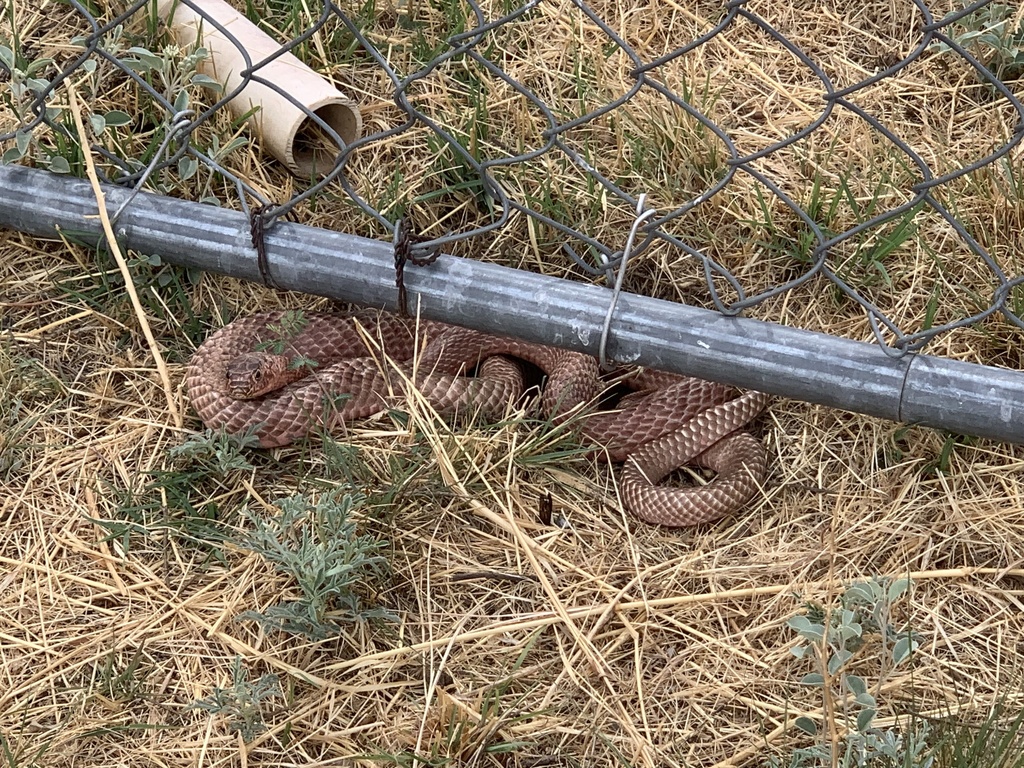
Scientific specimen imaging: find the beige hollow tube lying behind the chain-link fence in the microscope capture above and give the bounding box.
[158,0,362,178]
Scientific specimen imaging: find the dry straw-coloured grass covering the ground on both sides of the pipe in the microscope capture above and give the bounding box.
[0,0,1024,768]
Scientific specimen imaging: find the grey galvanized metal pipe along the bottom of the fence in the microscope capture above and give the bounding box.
[6,166,1024,442]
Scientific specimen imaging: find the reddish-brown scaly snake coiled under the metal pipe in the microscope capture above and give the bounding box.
[186,312,768,526]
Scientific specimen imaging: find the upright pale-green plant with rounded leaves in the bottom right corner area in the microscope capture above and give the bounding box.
[771,579,930,768]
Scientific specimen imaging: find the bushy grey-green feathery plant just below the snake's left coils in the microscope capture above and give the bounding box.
[239,493,392,640]
